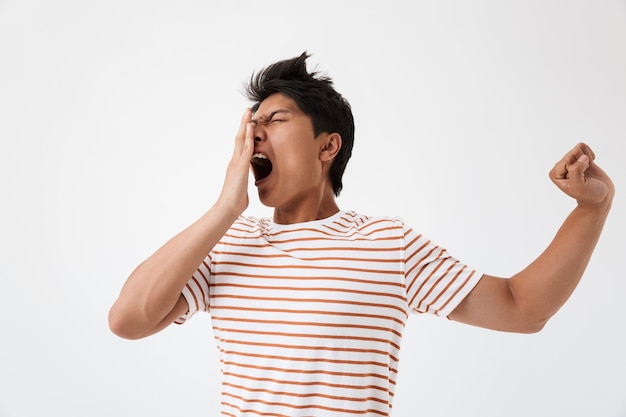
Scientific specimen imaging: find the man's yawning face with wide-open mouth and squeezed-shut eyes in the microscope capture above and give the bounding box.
[251,93,328,210]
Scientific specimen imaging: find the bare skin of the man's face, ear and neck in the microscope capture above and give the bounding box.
[246,94,341,223]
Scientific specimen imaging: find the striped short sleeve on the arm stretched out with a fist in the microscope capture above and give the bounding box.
[404,226,482,317]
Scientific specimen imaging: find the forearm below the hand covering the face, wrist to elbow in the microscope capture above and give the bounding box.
[109,205,238,338]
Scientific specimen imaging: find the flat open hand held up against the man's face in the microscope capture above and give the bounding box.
[218,109,254,215]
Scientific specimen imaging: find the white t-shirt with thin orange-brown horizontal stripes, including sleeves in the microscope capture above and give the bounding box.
[176,211,481,417]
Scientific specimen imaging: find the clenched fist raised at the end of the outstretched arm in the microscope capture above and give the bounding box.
[550,143,615,207]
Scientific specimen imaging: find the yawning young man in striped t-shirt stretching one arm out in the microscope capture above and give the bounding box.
[109,54,614,417]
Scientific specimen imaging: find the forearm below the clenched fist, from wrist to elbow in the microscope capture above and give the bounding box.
[509,199,611,323]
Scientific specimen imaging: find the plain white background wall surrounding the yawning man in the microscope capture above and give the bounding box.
[0,0,626,417]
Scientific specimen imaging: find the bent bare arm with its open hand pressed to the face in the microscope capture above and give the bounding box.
[109,109,254,339]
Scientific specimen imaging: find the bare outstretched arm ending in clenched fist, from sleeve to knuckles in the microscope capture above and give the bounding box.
[449,143,615,333]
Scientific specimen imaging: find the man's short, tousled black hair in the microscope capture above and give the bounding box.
[245,51,354,196]
